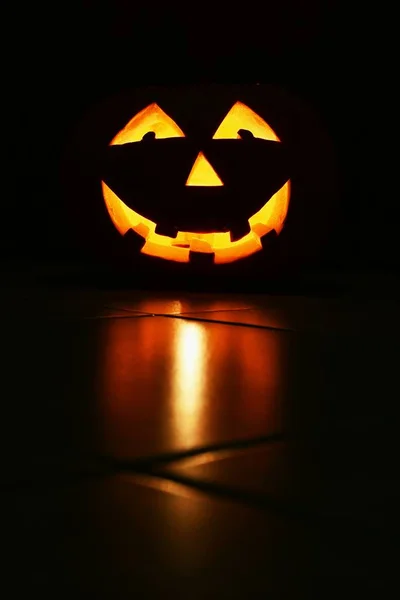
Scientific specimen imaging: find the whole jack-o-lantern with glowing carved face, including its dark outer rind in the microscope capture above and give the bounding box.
[64,85,335,281]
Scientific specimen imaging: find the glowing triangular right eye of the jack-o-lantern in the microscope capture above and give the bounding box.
[213,102,280,142]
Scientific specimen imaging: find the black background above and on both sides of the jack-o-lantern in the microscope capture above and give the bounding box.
[1,0,399,270]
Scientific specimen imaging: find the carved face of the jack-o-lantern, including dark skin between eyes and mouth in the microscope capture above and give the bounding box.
[102,101,290,264]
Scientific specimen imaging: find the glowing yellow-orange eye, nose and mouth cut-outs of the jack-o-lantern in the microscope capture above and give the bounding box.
[102,102,290,264]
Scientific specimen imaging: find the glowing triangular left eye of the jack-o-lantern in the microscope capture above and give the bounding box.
[110,102,185,146]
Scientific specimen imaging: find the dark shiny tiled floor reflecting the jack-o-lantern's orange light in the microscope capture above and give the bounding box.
[0,287,400,599]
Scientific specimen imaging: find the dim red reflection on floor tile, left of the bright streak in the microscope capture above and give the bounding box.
[98,316,172,455]
